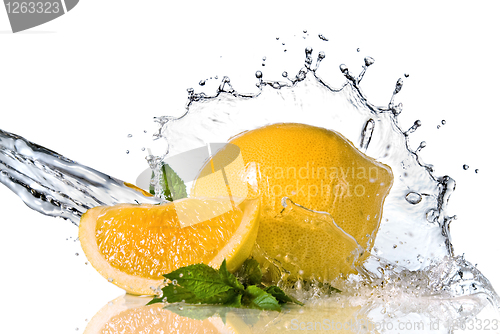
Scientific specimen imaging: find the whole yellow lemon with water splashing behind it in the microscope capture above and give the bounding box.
[191,123,393,280]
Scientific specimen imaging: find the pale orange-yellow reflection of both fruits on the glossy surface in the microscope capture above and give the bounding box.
[84,295,372,334]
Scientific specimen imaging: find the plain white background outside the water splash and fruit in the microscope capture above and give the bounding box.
[0,0,500,333]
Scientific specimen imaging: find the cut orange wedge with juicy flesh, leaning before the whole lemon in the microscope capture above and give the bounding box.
[79,198,260,295]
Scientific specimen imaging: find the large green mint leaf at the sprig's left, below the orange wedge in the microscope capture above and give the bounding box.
[156,263,238,304]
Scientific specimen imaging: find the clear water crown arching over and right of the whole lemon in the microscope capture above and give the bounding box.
[156,49,454,270]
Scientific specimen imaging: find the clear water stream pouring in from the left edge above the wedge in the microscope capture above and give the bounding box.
[0,130,159,225]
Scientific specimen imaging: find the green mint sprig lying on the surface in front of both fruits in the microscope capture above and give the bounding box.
[148,259,304,311]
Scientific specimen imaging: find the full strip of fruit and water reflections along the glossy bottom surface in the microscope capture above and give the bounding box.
[84,294,500,334]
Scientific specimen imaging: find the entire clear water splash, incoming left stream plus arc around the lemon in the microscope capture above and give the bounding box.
[0,48,498,316]
